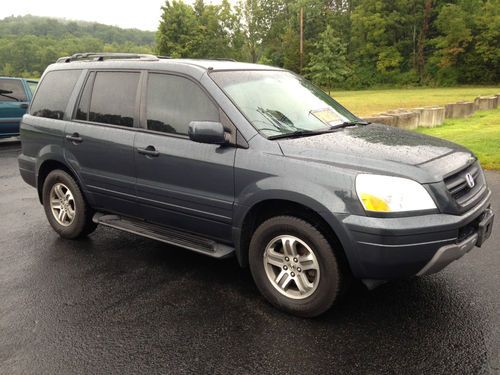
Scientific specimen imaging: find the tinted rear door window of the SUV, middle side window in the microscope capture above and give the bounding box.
[89,72,140,127]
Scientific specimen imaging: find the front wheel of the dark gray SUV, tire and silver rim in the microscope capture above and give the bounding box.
[249,216,343,317]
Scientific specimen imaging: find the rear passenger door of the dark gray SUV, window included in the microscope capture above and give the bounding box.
[65,71,141,216]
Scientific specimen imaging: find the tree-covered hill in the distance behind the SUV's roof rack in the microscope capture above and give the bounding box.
[0,16,155,77]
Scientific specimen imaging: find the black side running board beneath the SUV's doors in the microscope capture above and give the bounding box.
[92,213,234,258]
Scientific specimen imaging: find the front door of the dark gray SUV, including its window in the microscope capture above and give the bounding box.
[134,73,236,241]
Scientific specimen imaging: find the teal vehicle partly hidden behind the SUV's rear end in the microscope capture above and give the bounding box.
[0,77,38,138]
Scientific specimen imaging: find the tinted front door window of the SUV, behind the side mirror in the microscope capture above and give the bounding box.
[146,74,219,134]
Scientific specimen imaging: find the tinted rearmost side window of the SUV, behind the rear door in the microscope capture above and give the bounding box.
[31,70,81,120]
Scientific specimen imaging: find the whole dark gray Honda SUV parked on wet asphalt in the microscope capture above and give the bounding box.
[19,54,493,317]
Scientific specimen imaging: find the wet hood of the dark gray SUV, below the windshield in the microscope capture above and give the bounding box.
[279,124,476,182]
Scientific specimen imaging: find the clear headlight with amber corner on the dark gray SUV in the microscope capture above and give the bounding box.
[356,174,436,212]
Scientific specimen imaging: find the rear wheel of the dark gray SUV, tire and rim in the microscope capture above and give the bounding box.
[42,169,97,239]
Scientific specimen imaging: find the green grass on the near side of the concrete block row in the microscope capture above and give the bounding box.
[416,108,500,169]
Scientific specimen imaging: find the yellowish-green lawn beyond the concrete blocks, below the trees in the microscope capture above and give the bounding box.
[330,86,500,116]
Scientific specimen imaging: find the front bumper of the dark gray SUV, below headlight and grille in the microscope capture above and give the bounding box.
[343,191,494,280]
